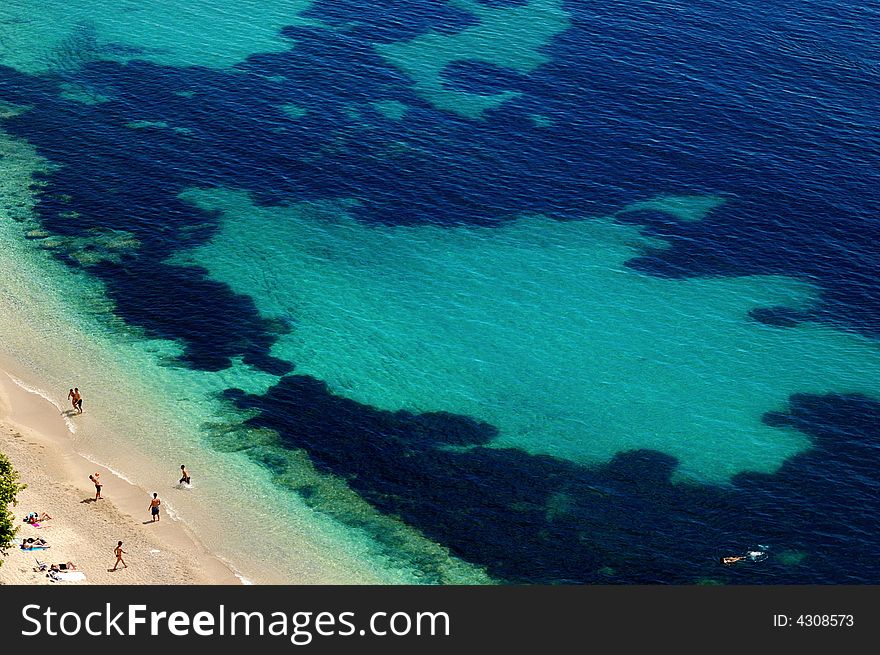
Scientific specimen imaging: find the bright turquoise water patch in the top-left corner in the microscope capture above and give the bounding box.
[0,0,309,74]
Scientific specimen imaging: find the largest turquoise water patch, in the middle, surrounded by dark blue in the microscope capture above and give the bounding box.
[183,190,880,484]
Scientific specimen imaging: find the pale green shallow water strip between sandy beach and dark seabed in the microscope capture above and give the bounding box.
[0,121,482,585]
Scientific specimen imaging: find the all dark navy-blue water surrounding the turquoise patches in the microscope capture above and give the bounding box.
[0,0,880,584]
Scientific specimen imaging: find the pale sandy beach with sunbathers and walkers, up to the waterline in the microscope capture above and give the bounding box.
[0,372,241,585]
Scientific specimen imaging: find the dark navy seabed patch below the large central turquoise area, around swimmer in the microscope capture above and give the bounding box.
[228,376,880,584]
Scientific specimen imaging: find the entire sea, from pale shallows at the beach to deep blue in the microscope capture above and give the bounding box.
[0,0,880,583]
